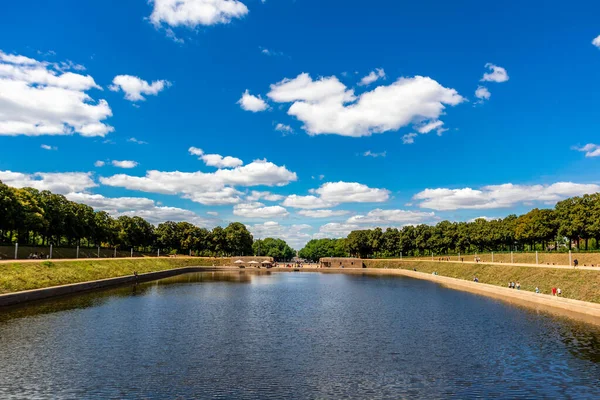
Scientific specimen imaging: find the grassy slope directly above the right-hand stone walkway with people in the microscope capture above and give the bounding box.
[365,260,600,303]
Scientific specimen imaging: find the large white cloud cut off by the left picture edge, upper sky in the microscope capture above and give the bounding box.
[0,51,114,137]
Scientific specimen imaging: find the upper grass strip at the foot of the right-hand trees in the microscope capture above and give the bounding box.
[414,252,600,266]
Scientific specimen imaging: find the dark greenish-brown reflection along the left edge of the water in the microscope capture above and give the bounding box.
[0,271,264,322]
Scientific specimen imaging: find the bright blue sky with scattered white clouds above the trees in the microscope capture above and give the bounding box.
[0,0,600,248]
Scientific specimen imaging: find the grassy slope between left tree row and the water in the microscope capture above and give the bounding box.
[0,257,231,294]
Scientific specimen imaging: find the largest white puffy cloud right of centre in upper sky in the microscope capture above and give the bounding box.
[267,73,465,137]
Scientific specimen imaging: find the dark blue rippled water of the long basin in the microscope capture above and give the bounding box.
[0,272,600,399]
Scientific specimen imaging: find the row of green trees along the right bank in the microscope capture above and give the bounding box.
[299,193,600,260]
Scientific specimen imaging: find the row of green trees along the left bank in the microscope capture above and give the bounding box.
[0,182,295,260]
